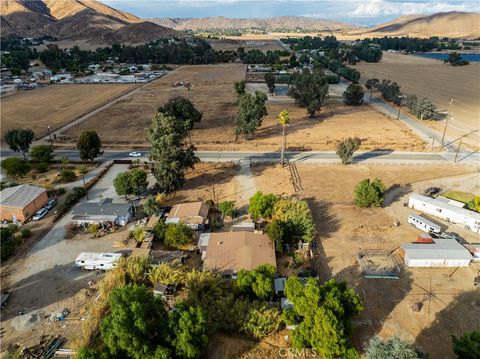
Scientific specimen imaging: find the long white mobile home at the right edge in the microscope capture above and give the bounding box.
[408,193,480,233]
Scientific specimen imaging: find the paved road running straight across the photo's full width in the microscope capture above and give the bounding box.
[1,150,480,165]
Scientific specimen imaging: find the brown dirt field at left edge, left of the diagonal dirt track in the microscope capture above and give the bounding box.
[1,84,138,137]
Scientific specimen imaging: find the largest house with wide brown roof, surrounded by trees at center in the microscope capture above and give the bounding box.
[203,231,277,276]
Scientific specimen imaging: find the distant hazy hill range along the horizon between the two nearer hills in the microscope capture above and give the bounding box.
[150,16,356,31]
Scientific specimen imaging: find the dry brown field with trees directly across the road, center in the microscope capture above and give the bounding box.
[65,64,427,151]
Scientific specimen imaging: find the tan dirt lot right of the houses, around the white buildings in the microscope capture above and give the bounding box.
[252,165,480,358]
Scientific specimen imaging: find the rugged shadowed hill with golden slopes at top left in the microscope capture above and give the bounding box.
[0,0,185,45]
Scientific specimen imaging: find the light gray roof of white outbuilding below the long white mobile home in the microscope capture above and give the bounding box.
[401,239,472,260]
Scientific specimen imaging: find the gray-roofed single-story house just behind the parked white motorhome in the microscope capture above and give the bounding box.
[71,198,135,226]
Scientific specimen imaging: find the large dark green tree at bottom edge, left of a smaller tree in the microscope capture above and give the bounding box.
[100,285,168,359]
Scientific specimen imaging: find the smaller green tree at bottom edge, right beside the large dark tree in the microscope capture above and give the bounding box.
[169,303,208,358]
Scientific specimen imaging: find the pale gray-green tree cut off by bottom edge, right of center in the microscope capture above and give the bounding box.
[365,336,421,359]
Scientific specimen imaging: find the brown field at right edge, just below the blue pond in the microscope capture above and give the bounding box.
[353,52,480,146]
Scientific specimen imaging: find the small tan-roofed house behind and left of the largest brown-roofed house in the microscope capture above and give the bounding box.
[165,202,210,230]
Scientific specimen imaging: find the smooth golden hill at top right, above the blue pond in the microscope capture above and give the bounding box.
[358,11,480,38]
